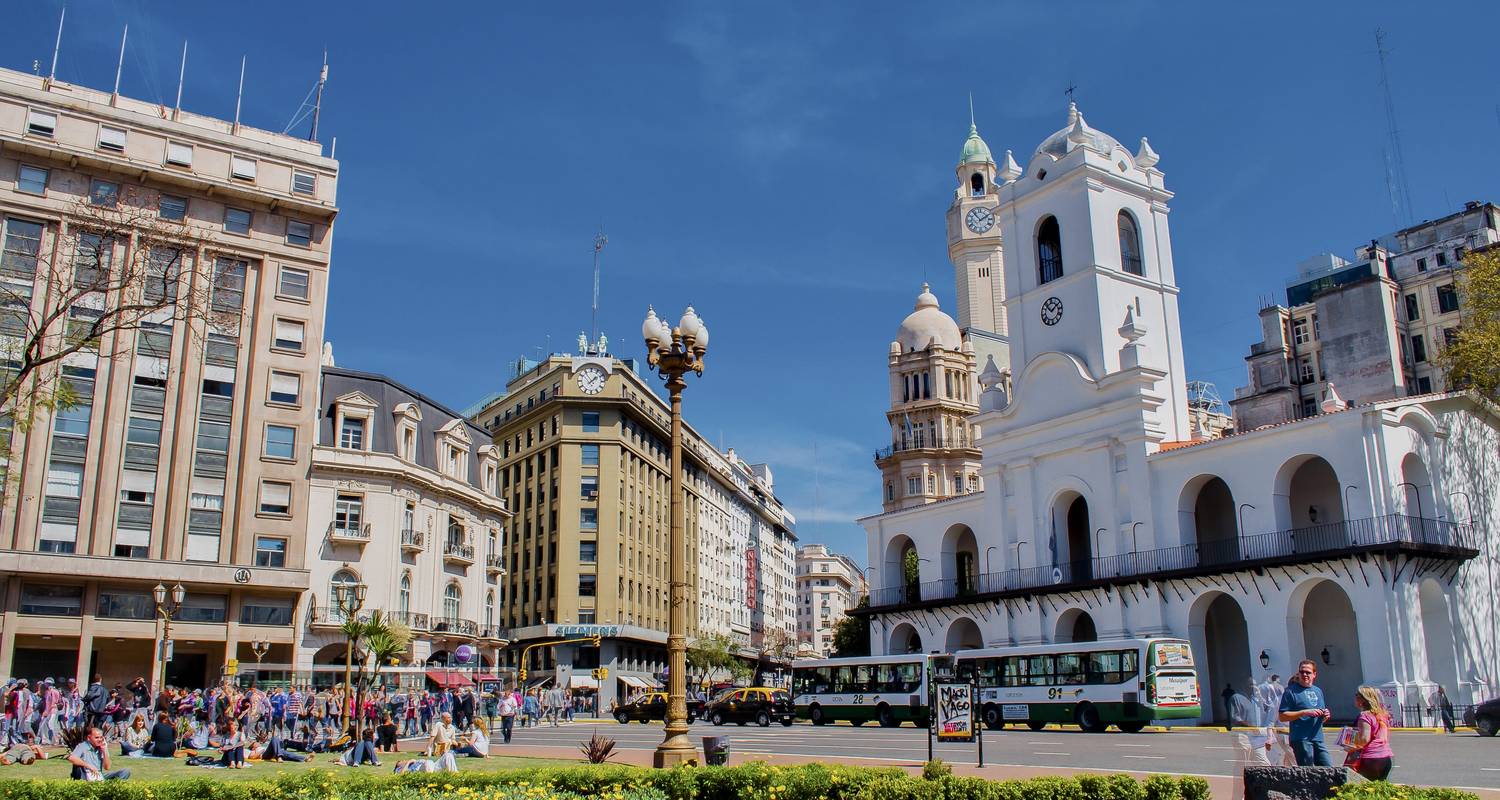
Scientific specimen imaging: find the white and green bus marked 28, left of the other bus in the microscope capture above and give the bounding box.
[792,653,927,728]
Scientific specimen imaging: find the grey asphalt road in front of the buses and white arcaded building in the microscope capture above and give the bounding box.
[491,720,1500,789]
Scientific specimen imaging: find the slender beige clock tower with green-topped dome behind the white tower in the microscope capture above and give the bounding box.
[948,120,1010,369]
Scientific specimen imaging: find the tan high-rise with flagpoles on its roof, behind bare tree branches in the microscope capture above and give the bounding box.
[0,71,338,686]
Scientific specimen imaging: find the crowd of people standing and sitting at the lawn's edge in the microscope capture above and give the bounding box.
[0,675,593,780]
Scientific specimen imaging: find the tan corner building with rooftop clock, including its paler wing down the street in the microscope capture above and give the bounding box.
[468,348,795,704]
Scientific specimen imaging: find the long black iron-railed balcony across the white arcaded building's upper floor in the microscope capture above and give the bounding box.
[848,515,1479,615]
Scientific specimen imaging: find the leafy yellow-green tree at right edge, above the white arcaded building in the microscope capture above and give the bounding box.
[1436,248,1500,401]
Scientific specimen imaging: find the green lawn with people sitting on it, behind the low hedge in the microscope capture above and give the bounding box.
[0,753,584,780]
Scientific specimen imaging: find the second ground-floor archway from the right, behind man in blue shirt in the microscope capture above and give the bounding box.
[1293,578,1365,719]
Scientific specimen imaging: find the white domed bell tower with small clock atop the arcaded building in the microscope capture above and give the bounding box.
[995,104,1191,441]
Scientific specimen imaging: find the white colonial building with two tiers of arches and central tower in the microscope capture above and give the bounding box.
[861,108,1500,719]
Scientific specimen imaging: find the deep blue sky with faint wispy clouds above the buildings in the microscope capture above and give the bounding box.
[0,0,1500,563]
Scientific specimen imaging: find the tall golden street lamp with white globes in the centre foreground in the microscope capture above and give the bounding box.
[641,306,708,767]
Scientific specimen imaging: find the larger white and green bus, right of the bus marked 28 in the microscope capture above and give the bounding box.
[956,638,1202,732]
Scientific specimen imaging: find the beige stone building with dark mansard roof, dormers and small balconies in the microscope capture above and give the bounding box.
[288,365,510,687]
